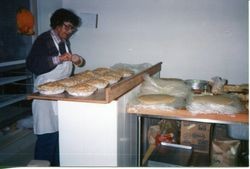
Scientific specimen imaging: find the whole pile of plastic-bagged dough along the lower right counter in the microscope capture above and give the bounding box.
[133,75,248,114]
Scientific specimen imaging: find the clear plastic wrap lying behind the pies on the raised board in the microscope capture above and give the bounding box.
[110,63,152,74]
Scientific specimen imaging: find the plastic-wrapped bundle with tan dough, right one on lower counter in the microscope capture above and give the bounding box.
[186,94,244,114]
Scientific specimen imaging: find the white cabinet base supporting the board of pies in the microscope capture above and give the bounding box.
[58,88,138,167]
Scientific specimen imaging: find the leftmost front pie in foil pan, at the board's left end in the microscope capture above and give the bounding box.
[37,82,65,95]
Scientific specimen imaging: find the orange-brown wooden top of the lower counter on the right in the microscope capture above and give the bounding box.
[127,106,249,124]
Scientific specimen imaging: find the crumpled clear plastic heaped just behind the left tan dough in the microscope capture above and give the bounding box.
[140,74,191,98]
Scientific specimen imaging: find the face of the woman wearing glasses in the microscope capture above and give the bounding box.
[55,22,76,40]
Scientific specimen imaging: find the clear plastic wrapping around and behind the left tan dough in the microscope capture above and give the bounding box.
[129,74,191,111]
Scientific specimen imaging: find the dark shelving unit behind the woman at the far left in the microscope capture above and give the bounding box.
[0,60,33,128]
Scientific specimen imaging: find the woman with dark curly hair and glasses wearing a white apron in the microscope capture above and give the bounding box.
[26,8,85,166]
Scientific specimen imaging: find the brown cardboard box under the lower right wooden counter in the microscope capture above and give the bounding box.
[180,121,211,153]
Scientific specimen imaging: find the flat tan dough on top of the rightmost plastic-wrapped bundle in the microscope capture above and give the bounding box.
[192,95,233,105]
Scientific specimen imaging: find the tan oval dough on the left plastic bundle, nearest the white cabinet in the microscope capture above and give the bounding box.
[138,94,175,104]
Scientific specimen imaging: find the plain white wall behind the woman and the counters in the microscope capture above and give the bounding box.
[62,0,248,83]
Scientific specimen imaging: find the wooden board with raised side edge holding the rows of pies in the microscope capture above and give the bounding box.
[27,62,162,103]
